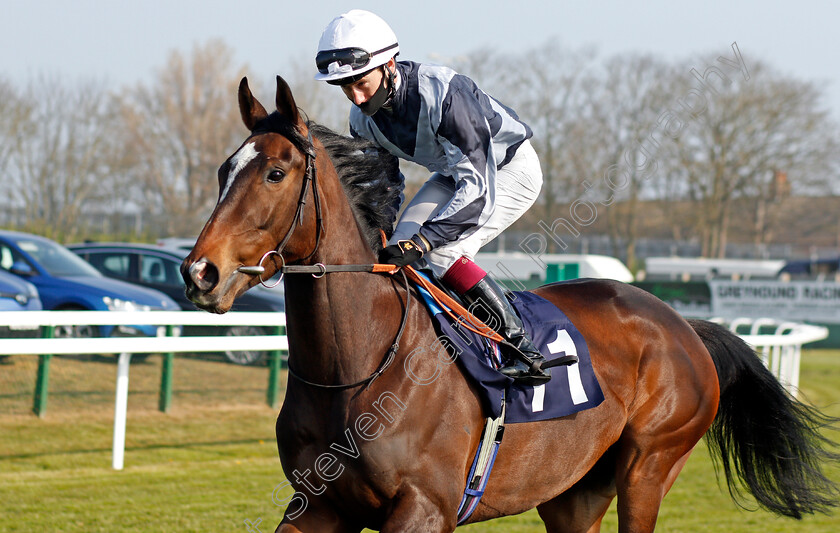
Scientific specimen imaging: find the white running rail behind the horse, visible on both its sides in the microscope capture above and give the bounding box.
[0,311,828,470]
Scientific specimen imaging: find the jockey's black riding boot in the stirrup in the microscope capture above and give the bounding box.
[464,276,564,385]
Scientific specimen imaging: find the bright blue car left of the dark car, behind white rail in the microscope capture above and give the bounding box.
[0,230,180,337]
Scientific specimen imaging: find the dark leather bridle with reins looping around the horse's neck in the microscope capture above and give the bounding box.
[236,124,411,390]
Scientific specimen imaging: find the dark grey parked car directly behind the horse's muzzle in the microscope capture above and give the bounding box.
[68,243,286,365]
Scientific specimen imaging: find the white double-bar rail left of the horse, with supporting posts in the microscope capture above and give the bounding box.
[0,311,289,470]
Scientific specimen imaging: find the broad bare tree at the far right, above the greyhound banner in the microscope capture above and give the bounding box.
[669,58,837,257]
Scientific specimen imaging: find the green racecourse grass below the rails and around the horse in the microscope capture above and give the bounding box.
[0,351,840,533]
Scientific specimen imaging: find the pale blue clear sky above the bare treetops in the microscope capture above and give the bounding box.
[0,0,840,119]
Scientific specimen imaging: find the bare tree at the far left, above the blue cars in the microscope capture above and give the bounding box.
[4,74,122,239]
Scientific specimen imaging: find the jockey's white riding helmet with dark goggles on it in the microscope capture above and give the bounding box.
[315,9,400,85]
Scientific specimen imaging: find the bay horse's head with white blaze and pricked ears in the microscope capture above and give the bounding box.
[181,76,319,313]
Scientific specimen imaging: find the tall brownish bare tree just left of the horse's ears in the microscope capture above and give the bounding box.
[120,40,247,235]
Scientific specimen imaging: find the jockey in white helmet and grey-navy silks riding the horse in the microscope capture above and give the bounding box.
[315,9,577,384]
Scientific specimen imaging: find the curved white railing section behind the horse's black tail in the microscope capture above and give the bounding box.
[712,318,828,397]
